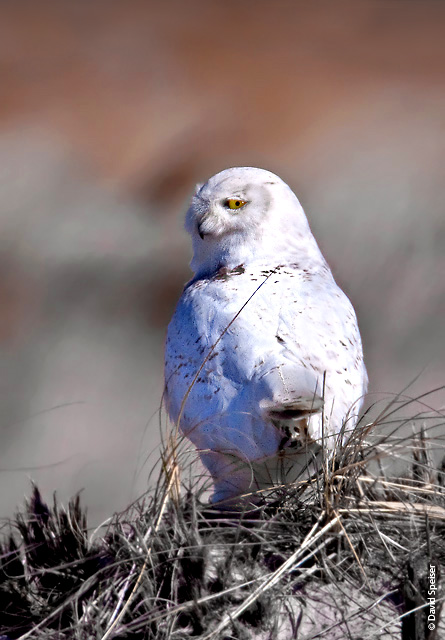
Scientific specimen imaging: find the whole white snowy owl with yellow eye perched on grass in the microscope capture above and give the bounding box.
[165,167,367,502]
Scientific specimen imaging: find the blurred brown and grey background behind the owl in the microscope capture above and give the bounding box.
[0,0,445,523]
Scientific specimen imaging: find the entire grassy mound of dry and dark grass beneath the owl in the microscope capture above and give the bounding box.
[0,392,445,640]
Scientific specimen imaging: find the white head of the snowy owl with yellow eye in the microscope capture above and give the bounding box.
[185,167,320,276]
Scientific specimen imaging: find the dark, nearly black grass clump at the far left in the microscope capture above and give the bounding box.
[0,486,113,638]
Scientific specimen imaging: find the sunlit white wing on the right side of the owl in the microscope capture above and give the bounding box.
[270,272,368,437]
